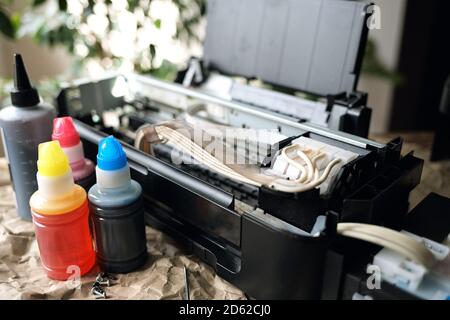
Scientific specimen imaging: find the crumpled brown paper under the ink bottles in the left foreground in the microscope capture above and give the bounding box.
[0,159,245,300]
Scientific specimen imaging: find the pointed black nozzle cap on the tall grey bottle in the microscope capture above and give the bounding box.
[11,53,40,107]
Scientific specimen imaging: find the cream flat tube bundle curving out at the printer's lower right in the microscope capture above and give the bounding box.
[337,223,435,268]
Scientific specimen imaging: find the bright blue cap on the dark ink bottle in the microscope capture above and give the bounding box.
[97,136,127,171]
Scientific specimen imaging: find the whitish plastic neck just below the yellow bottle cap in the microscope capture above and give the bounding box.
[36,170,74,199]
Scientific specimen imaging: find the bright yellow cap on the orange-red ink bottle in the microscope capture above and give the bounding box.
[37,141,70,177]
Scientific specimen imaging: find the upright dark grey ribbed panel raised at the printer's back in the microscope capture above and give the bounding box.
[203,0,369,96]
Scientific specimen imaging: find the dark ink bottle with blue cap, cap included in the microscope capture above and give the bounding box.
[88,136,147,273]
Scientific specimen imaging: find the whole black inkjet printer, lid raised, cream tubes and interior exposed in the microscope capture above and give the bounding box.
[57,0,450,299]
